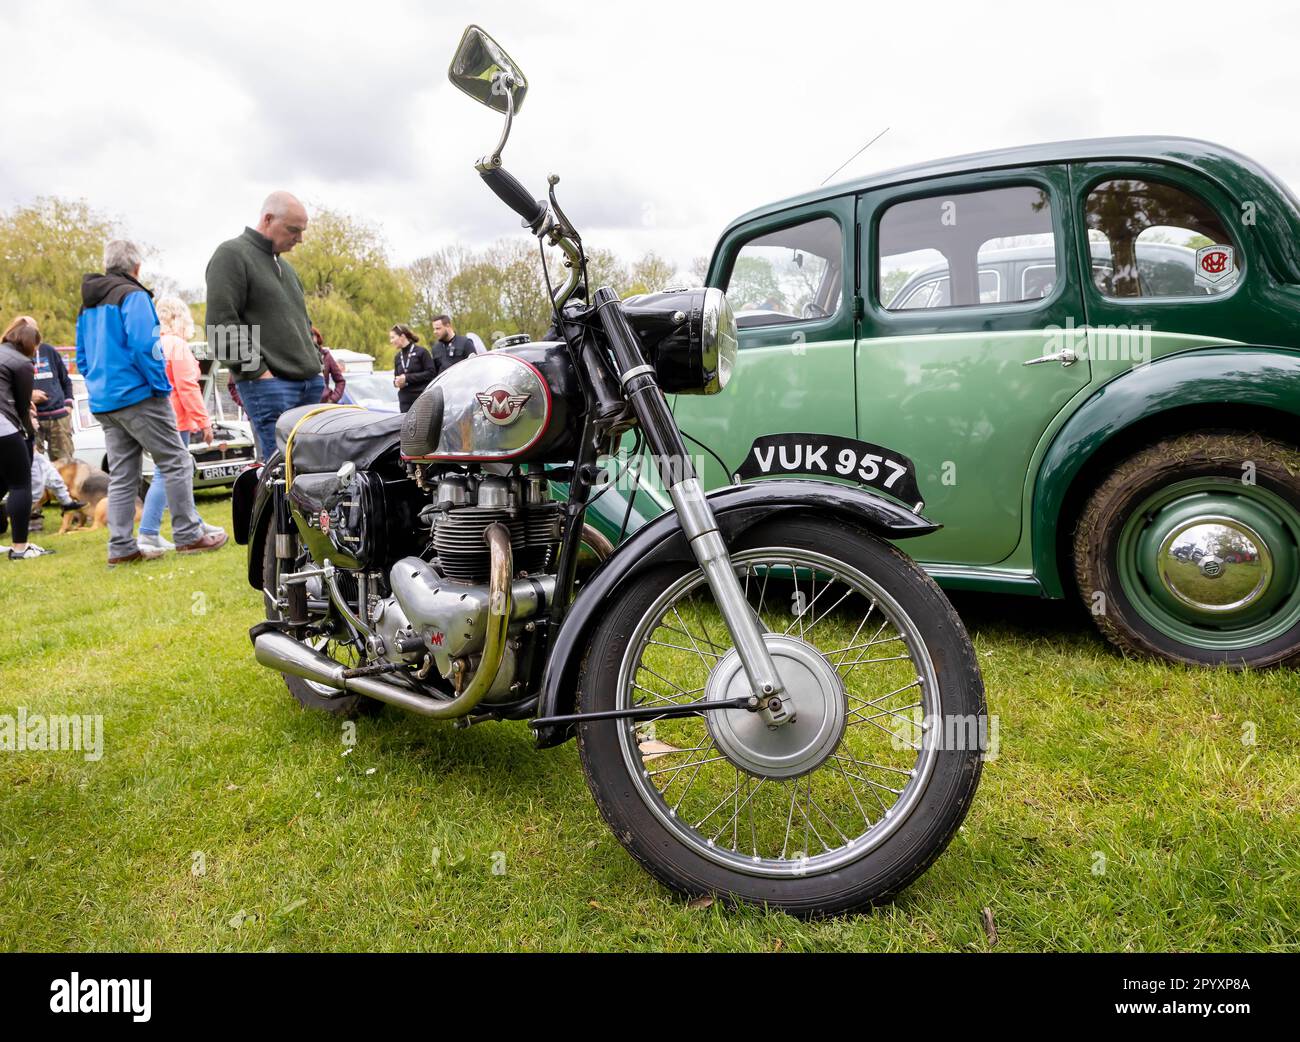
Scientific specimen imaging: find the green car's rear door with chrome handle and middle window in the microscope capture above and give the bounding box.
[855,166,1089,565]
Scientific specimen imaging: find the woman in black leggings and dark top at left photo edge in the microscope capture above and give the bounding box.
[0,314,53,561]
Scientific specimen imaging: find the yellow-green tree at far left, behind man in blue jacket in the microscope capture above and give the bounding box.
[0,196,121,344]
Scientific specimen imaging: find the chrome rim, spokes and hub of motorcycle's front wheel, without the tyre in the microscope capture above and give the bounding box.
[613,547,945,878]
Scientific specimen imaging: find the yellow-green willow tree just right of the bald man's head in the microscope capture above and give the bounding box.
[290,209,417,365]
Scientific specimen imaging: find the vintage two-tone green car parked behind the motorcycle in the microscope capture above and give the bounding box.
[618,138,1300,667]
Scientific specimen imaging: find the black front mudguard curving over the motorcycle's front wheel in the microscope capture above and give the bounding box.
[537,479,940,748]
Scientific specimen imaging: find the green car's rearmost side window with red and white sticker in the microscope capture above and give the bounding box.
[1084,179,1240,299]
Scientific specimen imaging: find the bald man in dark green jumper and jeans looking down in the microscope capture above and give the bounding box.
[208,192,325,460]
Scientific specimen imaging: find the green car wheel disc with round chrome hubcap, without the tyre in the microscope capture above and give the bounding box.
[1117,478,1300,651]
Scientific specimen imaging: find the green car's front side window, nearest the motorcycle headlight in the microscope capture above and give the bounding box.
[724,217,844,329]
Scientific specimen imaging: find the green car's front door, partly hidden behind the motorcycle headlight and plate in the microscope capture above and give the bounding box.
[673,196,857,489]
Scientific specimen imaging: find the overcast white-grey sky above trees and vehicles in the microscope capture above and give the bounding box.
[0,0,1300,288]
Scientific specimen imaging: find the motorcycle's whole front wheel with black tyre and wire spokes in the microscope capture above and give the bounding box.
[579,520,985,915]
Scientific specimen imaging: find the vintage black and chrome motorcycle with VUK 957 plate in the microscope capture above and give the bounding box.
[234,26,985,916]
